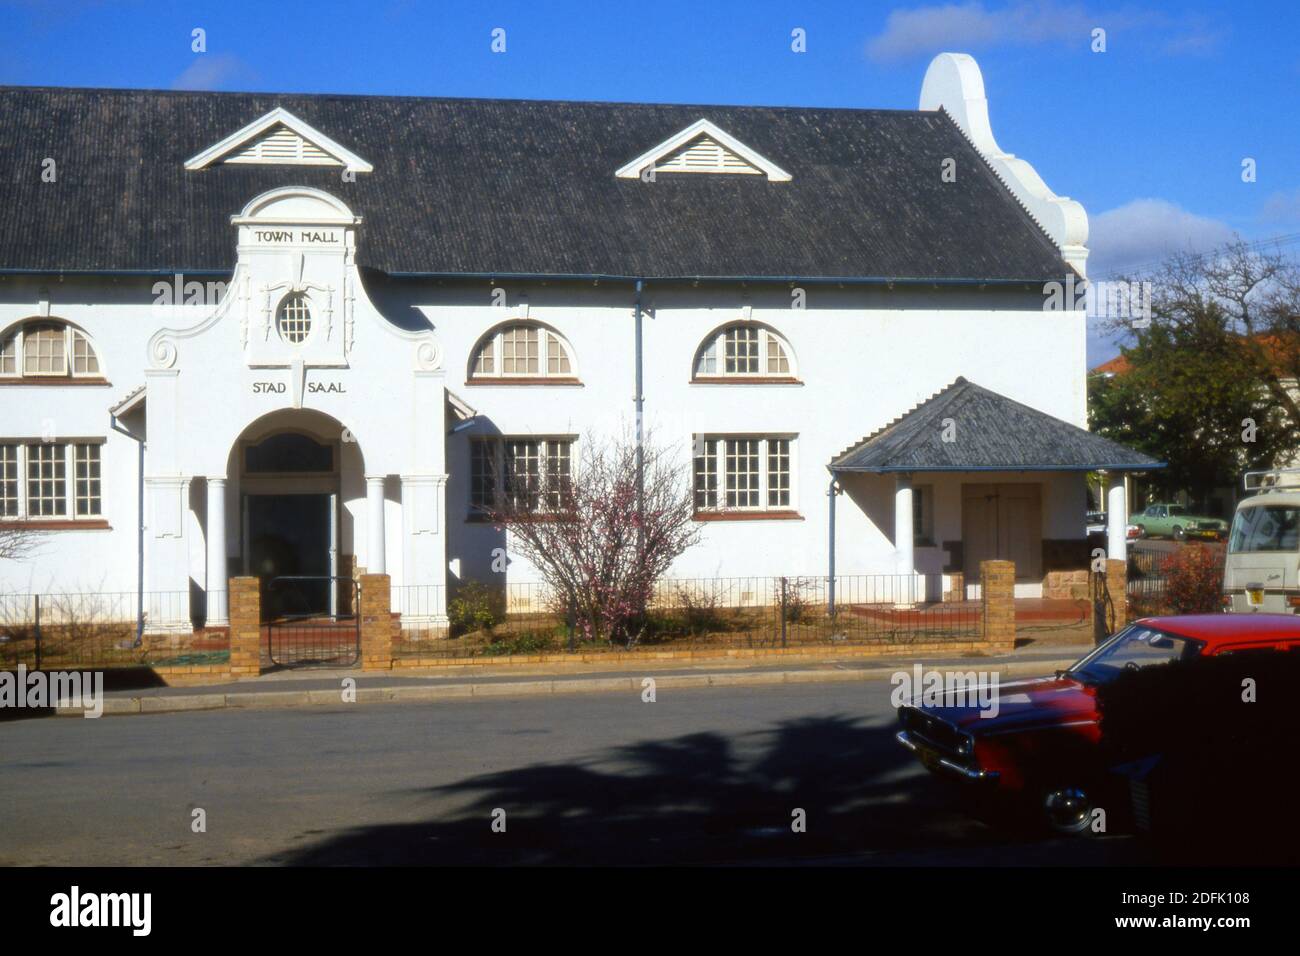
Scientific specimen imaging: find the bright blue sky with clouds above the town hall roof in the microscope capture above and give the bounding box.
[0,0,1300,362]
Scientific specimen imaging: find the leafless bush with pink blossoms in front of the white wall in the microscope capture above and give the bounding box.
[490,440,699,648]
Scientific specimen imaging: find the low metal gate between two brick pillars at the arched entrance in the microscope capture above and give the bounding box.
[263,575,361,667]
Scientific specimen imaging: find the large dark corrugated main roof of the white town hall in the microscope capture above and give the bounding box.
[0,87,1069,282]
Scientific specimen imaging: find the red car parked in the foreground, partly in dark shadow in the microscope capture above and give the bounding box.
[896,614,1300,832]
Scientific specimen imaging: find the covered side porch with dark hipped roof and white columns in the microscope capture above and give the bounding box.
[828,378,1164,604]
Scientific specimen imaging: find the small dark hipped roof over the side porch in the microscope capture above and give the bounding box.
[831,378,1165,472]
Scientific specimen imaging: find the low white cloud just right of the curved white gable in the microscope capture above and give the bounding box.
[1088,199,1235,278]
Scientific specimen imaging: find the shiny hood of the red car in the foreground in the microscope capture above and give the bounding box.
[911,678,1097,735]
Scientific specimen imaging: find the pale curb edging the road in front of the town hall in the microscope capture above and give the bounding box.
[55,657,1078,717]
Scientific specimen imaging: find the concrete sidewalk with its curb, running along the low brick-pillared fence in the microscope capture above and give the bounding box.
[57,644,1091,717]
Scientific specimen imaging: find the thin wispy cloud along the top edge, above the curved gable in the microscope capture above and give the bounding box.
[867,0,1218,61]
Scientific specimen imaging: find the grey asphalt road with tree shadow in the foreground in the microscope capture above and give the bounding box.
[0,682,1140,866]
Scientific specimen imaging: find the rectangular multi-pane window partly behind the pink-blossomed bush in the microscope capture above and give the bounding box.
[469,437,573,512]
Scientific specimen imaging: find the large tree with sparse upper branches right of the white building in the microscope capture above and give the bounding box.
[1088,242,1300,501]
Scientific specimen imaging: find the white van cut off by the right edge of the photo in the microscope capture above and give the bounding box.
[1223,468,1300,614]
